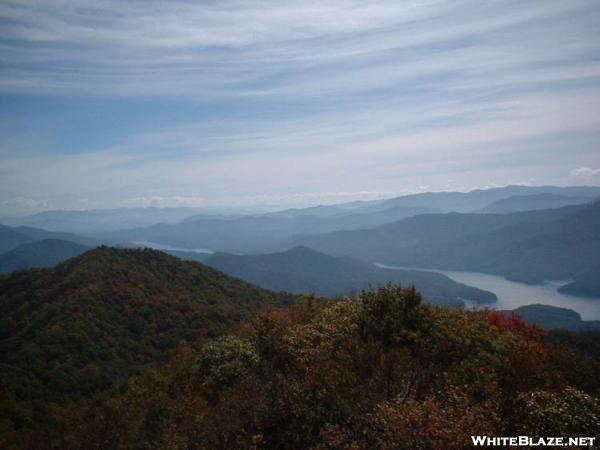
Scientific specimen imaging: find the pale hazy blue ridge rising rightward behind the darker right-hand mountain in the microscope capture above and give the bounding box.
[99,186,600,253]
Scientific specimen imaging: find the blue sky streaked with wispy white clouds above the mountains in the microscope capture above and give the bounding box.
[0,0,600,216]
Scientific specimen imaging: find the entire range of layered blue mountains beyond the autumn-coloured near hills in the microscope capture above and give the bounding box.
[0,186,600,302]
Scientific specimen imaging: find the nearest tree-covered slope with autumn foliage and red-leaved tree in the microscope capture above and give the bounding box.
[44,288,600,450]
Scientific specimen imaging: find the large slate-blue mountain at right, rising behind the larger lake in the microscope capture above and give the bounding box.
[290,202,600,295]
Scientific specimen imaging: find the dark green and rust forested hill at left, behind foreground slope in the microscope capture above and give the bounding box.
[0,247,292,432]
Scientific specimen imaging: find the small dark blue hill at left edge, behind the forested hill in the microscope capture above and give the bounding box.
[0,239,89,273]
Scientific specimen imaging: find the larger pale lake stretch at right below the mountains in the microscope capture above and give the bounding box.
[378,266,600,320]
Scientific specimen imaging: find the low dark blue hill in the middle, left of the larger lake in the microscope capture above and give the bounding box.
[204,247,496,305]
